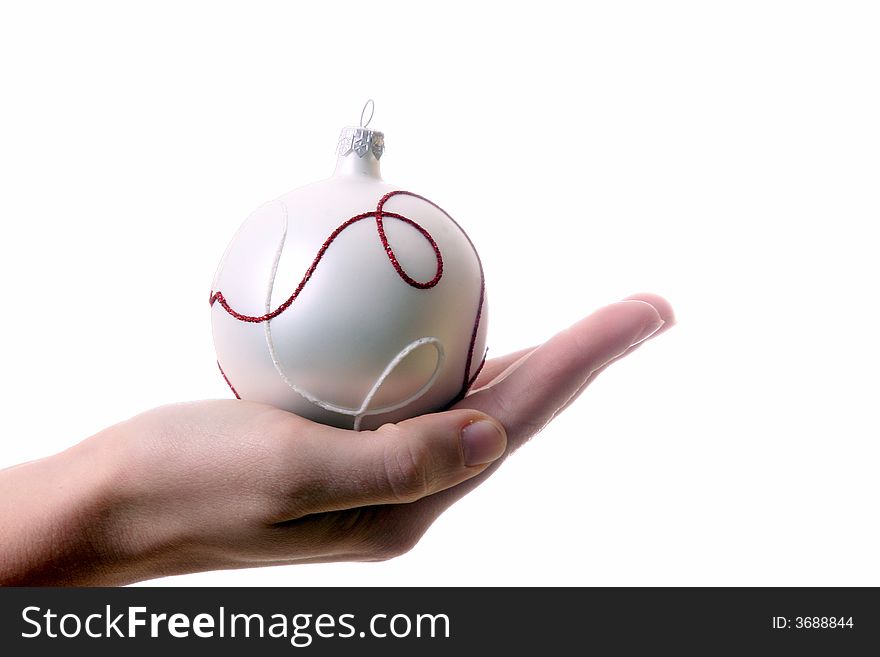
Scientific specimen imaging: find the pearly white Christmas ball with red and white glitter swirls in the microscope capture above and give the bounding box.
[210,104,487,430]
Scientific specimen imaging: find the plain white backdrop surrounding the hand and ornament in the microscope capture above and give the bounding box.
[0,0,880,586]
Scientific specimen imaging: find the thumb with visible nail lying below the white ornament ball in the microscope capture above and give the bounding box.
[279,410,507,520]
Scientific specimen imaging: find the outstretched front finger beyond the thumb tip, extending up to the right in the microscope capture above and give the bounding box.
[457,300,663,449]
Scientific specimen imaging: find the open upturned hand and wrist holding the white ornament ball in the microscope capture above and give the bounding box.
[0,295,674,585]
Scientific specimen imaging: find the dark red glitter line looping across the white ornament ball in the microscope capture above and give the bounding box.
[209,190,486,403]
